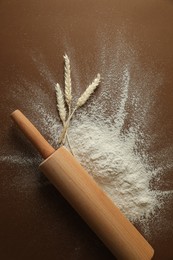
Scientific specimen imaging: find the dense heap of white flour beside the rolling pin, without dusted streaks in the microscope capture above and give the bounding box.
[70,117,157,220]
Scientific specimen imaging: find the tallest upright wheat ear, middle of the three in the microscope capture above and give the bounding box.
[64,54,72,106]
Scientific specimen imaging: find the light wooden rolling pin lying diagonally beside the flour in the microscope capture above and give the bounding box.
[11,110,154,260]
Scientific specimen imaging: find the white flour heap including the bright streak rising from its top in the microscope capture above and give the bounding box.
[66,66,171,222]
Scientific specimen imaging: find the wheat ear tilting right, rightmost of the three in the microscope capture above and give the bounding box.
[76,74,100,108]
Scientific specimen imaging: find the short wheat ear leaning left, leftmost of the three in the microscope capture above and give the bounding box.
[55,83,67,124]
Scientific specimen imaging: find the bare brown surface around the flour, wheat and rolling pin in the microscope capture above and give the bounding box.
[0,0,173,260]
